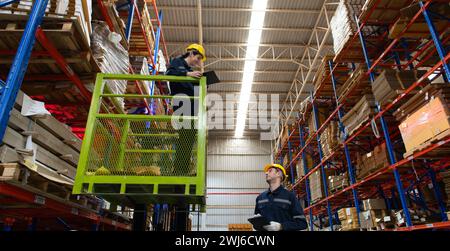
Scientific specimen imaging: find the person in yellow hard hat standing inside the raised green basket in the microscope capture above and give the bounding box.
[166,44,206,175]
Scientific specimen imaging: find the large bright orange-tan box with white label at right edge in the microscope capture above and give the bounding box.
[399,97,450,155]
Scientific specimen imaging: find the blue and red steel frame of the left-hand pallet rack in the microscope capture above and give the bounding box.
[0,0,168,230]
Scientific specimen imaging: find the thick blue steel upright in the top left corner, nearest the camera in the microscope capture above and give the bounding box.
[0,0,48,141]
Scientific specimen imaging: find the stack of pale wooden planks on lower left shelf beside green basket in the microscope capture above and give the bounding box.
[0,91,106,210]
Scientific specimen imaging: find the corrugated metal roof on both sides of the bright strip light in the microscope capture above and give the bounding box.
[157,0,335,135]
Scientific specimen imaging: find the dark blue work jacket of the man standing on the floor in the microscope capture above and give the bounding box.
[255,186,308,231]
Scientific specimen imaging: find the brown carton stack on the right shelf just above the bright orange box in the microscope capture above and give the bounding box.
[372,69,424,105]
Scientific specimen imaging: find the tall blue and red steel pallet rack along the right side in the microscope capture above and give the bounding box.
[274,0,450,231]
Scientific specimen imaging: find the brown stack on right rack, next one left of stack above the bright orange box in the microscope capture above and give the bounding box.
[342,94,375,135]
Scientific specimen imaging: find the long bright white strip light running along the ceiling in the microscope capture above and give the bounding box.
[234,0,268,138]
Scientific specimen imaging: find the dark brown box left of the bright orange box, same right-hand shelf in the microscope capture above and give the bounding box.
[356,143,389,180]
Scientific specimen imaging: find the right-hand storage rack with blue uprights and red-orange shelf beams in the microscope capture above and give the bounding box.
[274,0,450,231]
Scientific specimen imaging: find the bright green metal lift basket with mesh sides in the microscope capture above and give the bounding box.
[73,74,207,204]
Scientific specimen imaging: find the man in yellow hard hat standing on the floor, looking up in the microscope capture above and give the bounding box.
[255,164,308,231]
